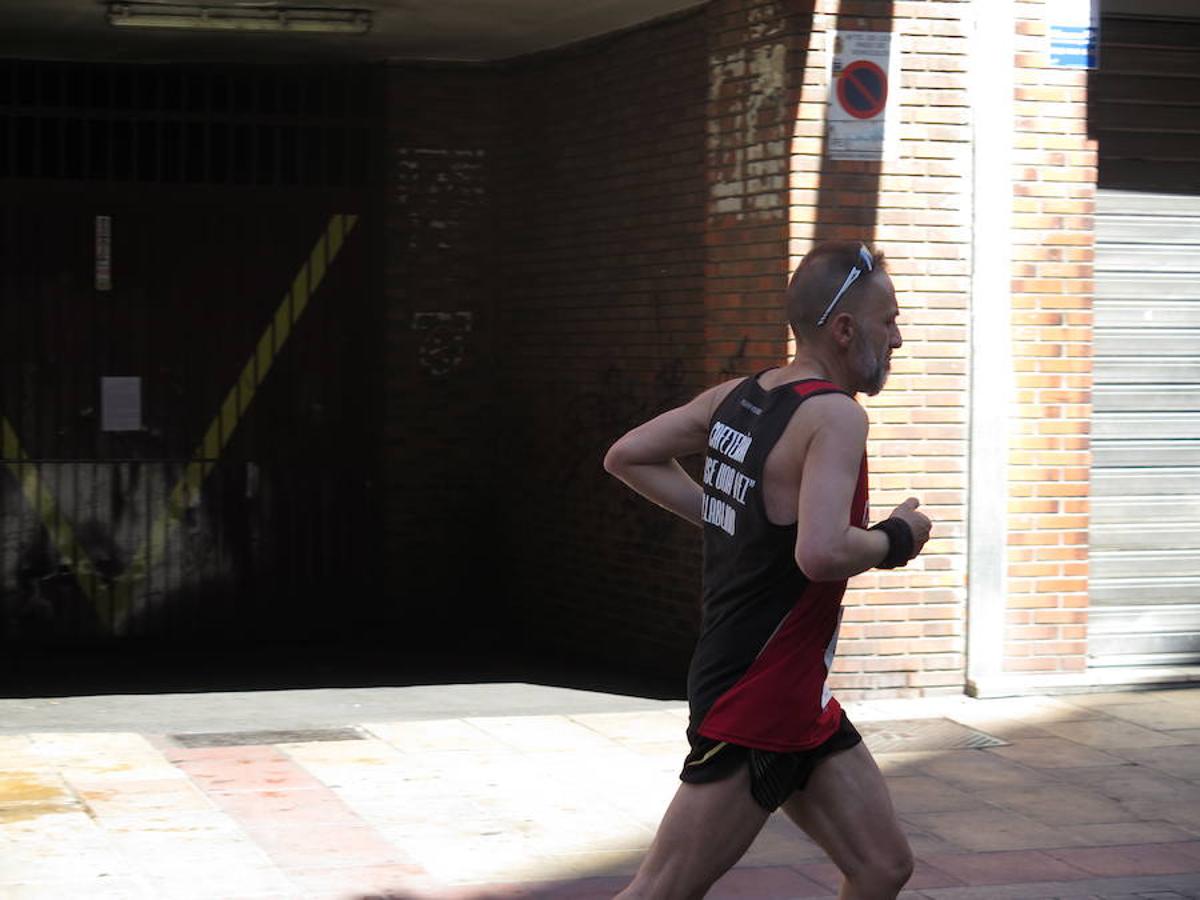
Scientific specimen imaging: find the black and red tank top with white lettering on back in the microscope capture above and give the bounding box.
[688,373,868,751]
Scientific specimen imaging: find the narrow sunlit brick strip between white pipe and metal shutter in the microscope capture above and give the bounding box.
[1004,0,1097,673]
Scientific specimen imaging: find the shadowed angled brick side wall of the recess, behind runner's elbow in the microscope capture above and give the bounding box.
[488,14,707,673]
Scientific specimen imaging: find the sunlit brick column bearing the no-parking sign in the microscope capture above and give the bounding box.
[788,0,972,698]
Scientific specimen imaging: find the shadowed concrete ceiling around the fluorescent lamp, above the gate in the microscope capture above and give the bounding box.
[0,0,701,62]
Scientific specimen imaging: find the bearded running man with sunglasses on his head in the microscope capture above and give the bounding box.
[605,242,930,900]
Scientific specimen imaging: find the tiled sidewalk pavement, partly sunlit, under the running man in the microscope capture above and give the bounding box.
[0,684,1200,900]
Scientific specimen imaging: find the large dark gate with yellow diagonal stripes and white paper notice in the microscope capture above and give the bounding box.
[0,62,376,644]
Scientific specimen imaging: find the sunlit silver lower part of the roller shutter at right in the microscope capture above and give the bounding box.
[1088,191,1200,665]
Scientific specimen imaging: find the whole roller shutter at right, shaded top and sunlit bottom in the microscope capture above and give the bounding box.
[1088,19,1200,666]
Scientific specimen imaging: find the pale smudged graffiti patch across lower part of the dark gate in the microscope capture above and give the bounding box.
[0,461,232,638]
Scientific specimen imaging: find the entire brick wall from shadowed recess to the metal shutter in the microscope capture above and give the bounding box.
[389,0,1096,697]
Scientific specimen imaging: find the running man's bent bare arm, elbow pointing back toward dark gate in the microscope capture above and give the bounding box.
[604,382,730,526]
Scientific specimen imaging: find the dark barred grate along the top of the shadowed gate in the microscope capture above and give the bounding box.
[0,60,373,187]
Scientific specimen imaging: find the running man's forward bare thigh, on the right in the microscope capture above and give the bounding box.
[782,743,910,875]
